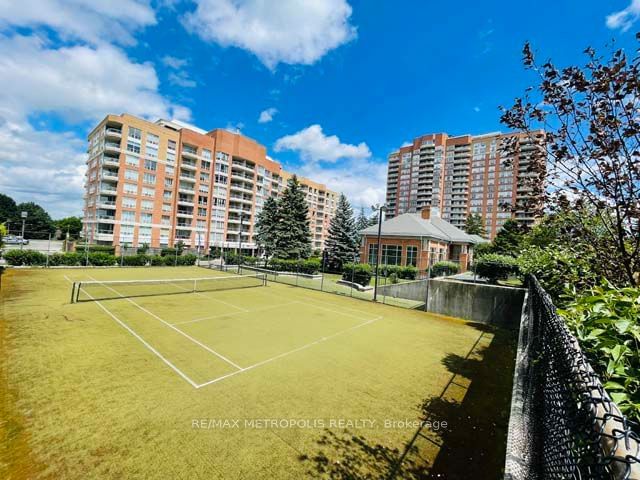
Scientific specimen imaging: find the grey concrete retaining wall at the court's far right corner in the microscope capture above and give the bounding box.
[378,279,525,328]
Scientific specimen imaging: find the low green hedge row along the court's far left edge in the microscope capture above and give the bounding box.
[3,250,197,267]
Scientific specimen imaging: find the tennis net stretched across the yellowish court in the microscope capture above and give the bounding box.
[71,274,267,303]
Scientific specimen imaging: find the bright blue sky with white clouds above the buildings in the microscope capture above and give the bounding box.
[0,0,640,217]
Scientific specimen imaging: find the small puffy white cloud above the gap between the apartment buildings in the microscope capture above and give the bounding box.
[274,125,371,162]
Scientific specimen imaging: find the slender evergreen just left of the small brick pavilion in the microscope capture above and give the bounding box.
[326,194,358,271]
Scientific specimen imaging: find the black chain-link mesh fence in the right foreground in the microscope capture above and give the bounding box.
[505,277,640,480]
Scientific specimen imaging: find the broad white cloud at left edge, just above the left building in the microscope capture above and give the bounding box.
[0,35,190,121]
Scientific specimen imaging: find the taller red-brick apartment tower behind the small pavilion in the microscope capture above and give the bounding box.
[386,131,544,238]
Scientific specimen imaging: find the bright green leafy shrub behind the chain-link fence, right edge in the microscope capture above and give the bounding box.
[558,283,640,423]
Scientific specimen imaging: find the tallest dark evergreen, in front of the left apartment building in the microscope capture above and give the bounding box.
[275,175,311,259]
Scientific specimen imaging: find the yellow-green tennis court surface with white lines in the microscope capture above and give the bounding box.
[0,267,514,479]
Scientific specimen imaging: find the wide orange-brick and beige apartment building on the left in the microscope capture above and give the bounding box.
[83,114,337,250]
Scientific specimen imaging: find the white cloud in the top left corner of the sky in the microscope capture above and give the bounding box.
[0,0,156,44]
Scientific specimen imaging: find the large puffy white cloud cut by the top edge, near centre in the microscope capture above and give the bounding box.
[183,0,356,69]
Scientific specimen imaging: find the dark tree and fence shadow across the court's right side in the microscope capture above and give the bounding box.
[299,325,517,480]
